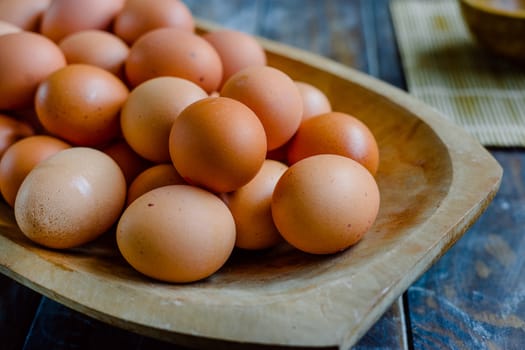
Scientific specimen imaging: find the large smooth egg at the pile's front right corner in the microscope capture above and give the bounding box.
[271,154,380,254]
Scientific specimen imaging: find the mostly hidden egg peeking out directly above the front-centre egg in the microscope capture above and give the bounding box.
[127,164,187,205]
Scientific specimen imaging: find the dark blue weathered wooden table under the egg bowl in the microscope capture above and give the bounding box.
[0,0,525,350]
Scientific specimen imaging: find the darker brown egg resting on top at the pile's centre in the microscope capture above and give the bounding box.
[169,97,266,193]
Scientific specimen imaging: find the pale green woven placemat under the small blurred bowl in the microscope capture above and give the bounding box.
[391,0,525,146]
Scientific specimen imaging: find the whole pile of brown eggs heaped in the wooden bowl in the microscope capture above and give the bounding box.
[0,0,379,282]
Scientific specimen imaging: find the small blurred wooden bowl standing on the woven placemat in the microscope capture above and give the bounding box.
[460,0,525,63]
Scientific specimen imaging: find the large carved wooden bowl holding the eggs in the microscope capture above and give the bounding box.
[0,22,502,349]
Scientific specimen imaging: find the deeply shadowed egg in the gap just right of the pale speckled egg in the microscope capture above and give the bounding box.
[101,139,151,185]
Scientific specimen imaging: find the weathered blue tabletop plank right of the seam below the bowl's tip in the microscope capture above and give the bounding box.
[408,149,525,350]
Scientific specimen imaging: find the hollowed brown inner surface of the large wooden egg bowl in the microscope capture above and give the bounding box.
[0,52,453,303]
